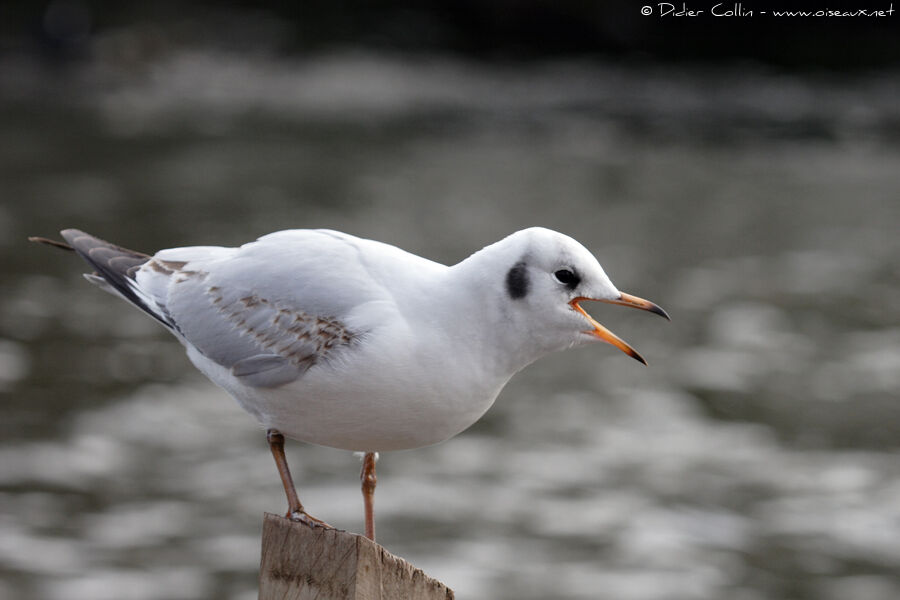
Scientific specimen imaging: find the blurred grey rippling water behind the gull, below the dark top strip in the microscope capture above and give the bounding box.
[0,2,900,600]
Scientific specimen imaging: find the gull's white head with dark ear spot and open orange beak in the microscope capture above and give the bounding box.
[463,227,669,366]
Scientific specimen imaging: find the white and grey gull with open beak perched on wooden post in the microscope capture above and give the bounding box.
[29,227,669,540]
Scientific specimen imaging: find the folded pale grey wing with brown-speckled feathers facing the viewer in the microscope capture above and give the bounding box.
[135,230,391,387]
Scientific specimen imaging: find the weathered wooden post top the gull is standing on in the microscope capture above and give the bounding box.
[259,513,454,600]
